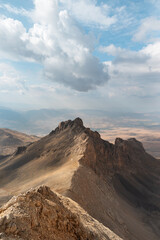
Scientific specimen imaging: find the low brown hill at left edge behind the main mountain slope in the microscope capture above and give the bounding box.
[0,128,39,155]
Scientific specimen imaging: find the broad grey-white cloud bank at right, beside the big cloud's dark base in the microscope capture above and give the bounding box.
[100,42,160,98]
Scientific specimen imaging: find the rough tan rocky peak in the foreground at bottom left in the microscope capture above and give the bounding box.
[0,186,121,240]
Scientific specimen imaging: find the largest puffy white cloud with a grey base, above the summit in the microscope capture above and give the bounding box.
[0,0,109,91]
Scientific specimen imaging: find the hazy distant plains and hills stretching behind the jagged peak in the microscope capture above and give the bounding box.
[0,107,160,158]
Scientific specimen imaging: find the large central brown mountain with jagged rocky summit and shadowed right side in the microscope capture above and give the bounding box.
[0,118,160,240]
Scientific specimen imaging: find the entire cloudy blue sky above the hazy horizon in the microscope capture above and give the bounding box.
[0,0,160,112]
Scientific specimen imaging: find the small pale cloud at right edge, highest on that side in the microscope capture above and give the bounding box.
[133,17,160,42]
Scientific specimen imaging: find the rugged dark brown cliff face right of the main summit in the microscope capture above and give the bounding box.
[81,123,159,176]
